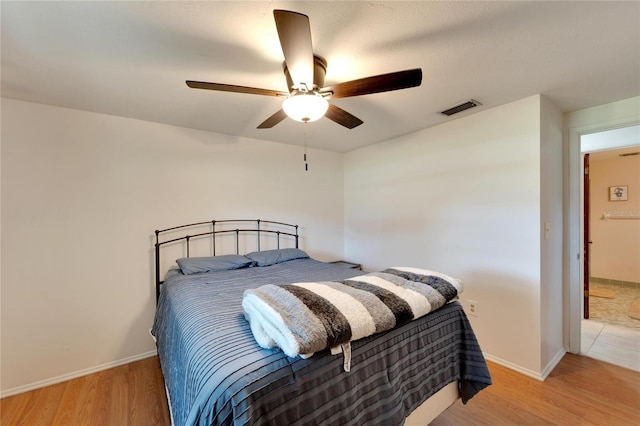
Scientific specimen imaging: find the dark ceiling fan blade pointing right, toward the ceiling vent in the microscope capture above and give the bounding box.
[320,68,422,99]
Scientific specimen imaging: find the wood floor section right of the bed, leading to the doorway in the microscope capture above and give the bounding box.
[431,354,640,426]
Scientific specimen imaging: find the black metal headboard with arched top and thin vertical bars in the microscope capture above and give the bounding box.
[155,219,299,302]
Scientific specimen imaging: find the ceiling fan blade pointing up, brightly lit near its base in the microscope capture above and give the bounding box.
[273,9,313,90]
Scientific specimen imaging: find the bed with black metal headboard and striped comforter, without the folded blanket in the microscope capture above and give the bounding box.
[151,220,491,426]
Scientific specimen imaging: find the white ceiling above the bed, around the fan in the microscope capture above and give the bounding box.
[0,0,640,152]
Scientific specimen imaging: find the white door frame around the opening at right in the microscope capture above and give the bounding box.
[563,119,640,354]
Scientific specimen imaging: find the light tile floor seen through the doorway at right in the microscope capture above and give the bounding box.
[580,283,640,371]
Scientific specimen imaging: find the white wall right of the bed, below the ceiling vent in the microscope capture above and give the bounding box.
[345,96,562,377]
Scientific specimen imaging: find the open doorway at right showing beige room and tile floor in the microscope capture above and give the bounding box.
[572,126,640,371]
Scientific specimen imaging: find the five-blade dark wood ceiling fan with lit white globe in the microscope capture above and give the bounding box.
[186,10,422,129]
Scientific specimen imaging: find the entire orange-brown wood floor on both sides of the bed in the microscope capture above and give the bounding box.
[0,354,640,426]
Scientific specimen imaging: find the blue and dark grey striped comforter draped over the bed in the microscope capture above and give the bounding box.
[152,259,491,425]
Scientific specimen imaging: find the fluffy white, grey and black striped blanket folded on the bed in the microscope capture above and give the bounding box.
[242,267,462,371]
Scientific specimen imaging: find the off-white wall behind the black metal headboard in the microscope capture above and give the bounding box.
[1,99,343,395]
